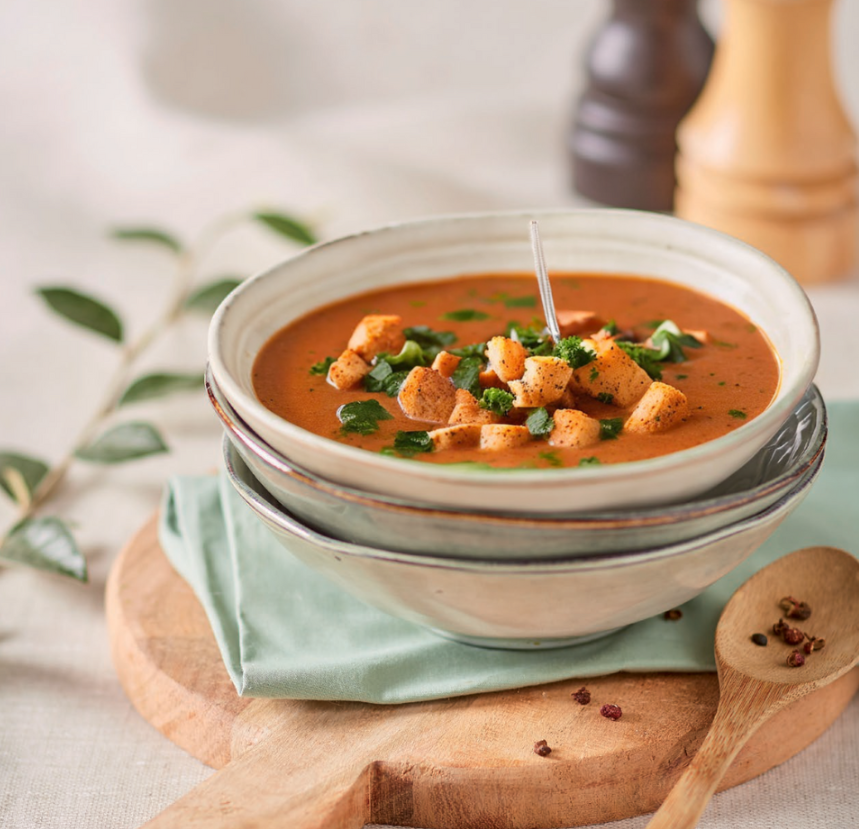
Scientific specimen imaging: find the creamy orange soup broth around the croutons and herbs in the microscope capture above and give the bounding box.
[253,273,779,468]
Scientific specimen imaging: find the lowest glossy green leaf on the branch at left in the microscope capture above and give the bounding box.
[0,517,87,582]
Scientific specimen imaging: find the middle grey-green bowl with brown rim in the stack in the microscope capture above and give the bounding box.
[206,373,827,561]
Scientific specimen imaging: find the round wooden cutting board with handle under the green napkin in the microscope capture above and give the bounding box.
[107,519,859,829]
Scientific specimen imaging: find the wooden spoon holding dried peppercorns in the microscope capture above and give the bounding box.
[647,547,859,829]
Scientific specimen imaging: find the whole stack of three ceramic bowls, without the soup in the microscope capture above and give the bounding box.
[207,210,826,648]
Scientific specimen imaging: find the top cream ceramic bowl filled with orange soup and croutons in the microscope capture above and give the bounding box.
[209,209,819,514]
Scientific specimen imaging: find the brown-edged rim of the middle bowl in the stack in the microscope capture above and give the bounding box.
[205,367,828,531]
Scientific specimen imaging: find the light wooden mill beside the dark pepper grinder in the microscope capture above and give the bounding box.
[675,0,859,284]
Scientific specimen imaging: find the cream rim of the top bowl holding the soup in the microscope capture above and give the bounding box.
[208,207,820,490]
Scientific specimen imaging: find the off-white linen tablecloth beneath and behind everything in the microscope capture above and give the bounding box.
[0,0,859,829]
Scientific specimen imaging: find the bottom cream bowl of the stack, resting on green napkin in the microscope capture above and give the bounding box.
[224,438,820,649]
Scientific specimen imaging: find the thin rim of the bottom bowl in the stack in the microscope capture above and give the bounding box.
[224,437,822,575]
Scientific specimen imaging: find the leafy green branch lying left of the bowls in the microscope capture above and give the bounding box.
[0,211,316,581]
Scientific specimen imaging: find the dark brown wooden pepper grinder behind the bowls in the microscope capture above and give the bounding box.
[569,0,714,210]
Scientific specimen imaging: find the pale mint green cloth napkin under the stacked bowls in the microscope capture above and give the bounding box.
[160,401,859,703]
